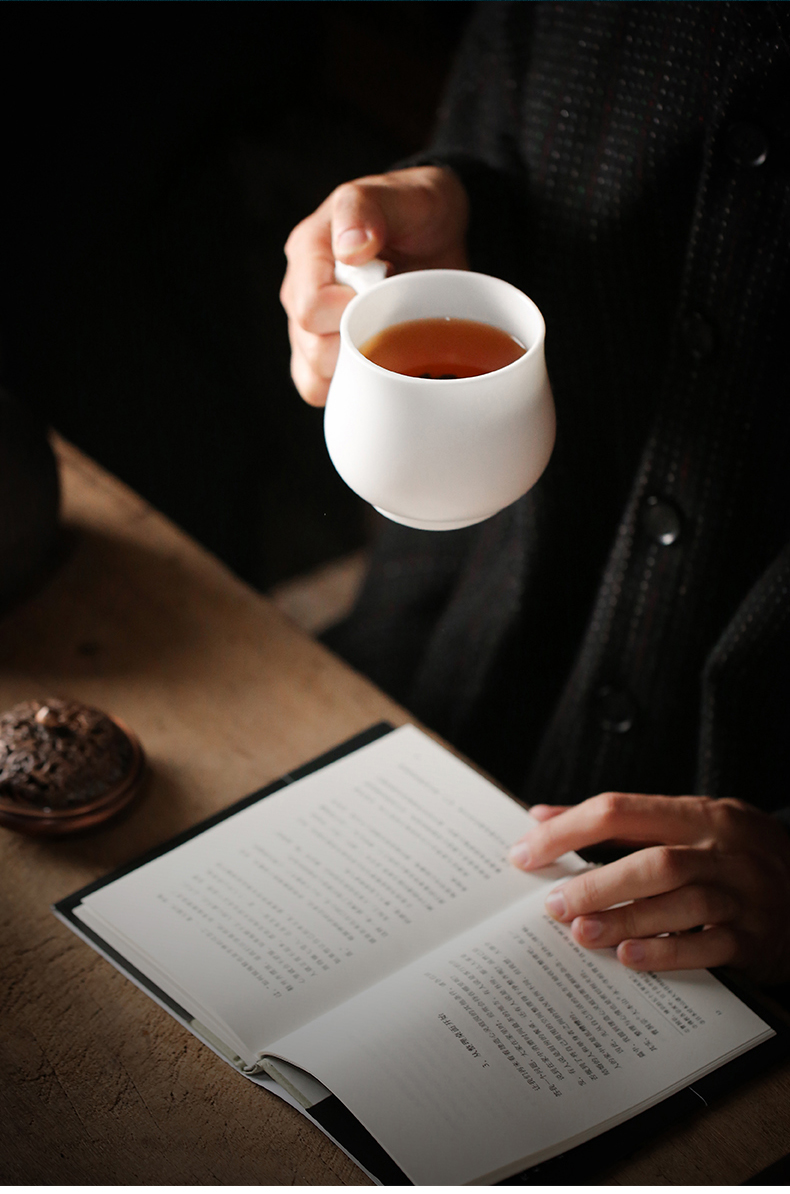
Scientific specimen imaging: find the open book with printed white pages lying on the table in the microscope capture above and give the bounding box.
[55,726,772,1184]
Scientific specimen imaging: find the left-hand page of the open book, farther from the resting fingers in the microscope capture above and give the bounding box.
[75,726,584,1064]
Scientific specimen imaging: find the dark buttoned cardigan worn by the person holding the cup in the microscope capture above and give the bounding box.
[328,0,790,811]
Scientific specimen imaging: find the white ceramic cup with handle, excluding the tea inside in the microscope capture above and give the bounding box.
[323,263,555,530]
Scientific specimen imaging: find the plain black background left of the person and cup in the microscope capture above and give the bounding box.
[0,0,473,589]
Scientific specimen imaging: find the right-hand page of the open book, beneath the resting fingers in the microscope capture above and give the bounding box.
[273,893,772,1184]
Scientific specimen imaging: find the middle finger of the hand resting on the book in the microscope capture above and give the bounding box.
[545,845,735,923]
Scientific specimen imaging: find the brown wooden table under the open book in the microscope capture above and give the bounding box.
[0,442,790,1184]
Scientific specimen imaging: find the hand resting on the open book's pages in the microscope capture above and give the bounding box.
[511,792,790,983]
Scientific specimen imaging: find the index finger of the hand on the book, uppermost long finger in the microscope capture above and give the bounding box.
[513,792,714,870]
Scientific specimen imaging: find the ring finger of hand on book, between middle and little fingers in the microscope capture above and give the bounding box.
[570,884,740,949]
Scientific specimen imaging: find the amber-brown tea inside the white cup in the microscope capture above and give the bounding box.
[359,315,526,381]
